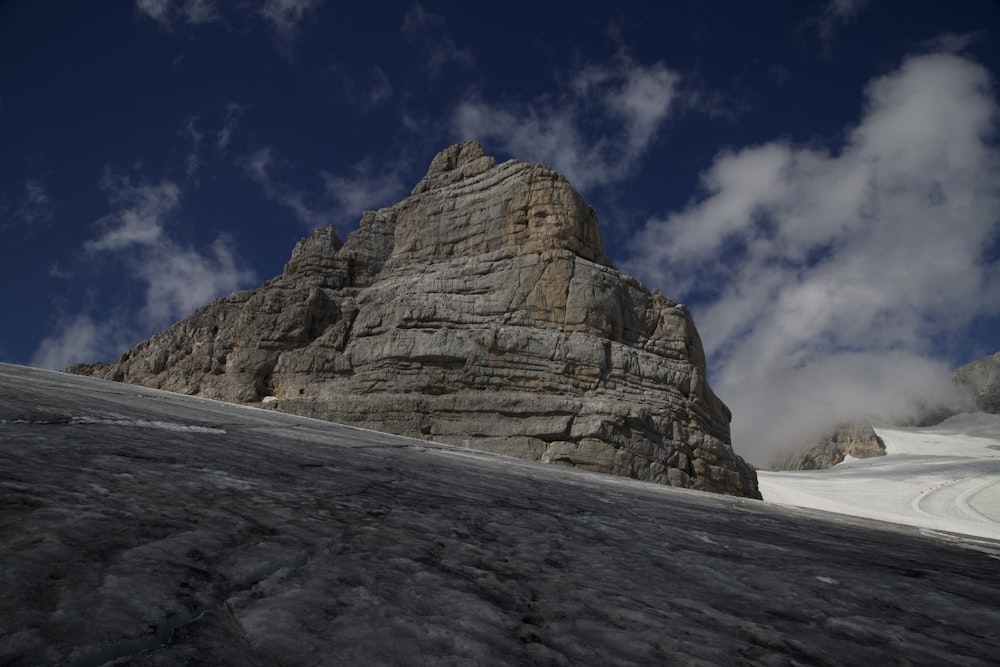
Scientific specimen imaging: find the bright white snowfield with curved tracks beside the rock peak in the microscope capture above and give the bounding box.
[758,412,1000,539]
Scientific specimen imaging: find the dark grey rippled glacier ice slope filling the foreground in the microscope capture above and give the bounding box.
[0,365,1000,666]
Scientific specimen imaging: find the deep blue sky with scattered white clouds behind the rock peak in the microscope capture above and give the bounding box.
[0,0,1000,462]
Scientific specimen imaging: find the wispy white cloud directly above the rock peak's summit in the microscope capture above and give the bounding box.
[452,55,680,190]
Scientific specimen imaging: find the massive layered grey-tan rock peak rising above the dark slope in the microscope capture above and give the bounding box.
[69,143,759,497]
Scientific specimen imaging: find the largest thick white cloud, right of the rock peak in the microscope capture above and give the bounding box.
[626,54,1000,463]
